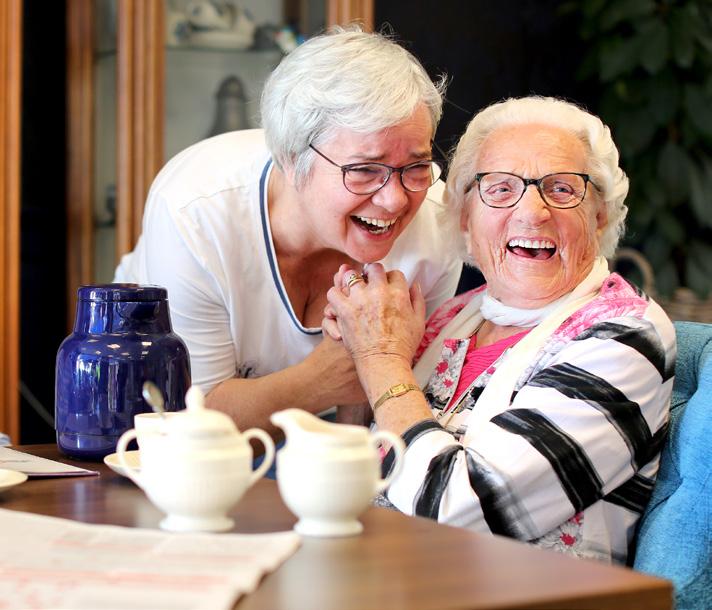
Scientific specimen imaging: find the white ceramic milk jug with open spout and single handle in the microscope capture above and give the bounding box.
[270,409,405,536]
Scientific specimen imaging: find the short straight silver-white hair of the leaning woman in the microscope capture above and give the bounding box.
[260,26,445,184]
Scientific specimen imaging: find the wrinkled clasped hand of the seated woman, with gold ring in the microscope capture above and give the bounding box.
[322,263,425,367]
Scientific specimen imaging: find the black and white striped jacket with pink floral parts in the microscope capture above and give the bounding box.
[383,274,676,563]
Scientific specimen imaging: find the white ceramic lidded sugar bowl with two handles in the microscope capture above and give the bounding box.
[116,386,274,532]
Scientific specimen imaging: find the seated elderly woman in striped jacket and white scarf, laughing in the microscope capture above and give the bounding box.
[323,97,675,562]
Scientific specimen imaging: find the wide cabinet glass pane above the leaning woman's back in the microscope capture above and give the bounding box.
[164,0,308,159]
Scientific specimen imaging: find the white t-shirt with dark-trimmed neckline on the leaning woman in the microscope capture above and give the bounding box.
[114,129,462,392]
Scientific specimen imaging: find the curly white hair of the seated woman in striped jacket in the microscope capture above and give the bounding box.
[445,96,628,263]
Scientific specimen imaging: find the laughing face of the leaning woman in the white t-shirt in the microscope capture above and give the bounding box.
[295,106,432,263]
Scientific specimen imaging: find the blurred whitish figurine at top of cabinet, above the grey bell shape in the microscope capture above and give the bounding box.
[185,0,257,49]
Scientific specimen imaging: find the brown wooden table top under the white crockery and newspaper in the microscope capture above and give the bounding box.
[0,445,672,610]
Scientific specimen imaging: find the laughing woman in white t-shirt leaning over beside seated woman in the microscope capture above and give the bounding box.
[116,27,462,435]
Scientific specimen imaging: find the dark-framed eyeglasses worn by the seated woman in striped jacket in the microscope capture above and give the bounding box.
[465,172,600,209]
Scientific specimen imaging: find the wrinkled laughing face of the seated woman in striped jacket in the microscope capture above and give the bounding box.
[462,124,607,309]
